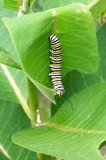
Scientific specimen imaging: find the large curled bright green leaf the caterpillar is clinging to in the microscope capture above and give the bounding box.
[4,4,98,101]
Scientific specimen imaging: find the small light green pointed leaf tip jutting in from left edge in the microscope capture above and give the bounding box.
[0,47,21,69]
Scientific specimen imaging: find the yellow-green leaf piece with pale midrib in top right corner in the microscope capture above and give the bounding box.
[88,0,106,18]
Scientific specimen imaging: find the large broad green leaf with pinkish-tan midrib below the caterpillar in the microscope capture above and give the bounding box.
[13,83,106,160]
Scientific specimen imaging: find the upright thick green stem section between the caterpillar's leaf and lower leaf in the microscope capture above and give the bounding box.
[27,78,38,127]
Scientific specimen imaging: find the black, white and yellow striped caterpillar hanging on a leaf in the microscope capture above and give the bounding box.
[49,35,65,97]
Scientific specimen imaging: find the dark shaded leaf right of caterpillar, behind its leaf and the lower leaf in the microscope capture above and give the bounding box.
[51,23,106,115]
